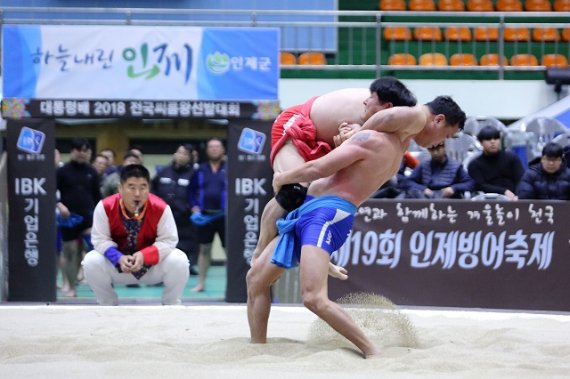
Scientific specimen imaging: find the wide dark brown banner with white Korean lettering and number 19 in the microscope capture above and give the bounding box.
[329,200,570,311]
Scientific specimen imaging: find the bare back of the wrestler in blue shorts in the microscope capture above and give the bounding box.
[308,131,408,205]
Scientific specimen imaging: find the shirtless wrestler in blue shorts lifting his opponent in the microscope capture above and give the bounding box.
[247,96,465,358]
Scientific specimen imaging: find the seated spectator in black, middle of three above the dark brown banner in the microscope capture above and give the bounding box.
[467,125,524,200]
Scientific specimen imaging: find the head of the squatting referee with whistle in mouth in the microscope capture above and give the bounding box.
[119,164,150,215]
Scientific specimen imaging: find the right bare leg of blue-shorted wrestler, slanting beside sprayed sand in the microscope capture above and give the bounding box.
[299,245,380,358]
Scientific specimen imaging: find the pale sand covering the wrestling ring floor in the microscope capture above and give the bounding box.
[0,296,570,379]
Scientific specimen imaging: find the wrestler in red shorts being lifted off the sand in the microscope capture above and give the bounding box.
[252,77,416,270]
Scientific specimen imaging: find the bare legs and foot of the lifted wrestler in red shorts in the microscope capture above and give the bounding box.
[252,142,348,280]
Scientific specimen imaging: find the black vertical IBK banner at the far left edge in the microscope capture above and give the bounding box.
[6,119,56,302]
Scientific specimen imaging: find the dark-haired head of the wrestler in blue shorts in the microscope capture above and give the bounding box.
[414,96,466,147]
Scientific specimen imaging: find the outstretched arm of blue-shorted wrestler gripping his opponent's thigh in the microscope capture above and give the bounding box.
[273,131,373,193]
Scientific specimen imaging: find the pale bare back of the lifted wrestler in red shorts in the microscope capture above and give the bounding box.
[311,88,370,146]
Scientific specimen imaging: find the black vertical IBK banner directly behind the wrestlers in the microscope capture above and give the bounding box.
[226,120,273,303]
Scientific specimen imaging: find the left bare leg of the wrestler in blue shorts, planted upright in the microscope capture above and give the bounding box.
[246,238,284,343]
